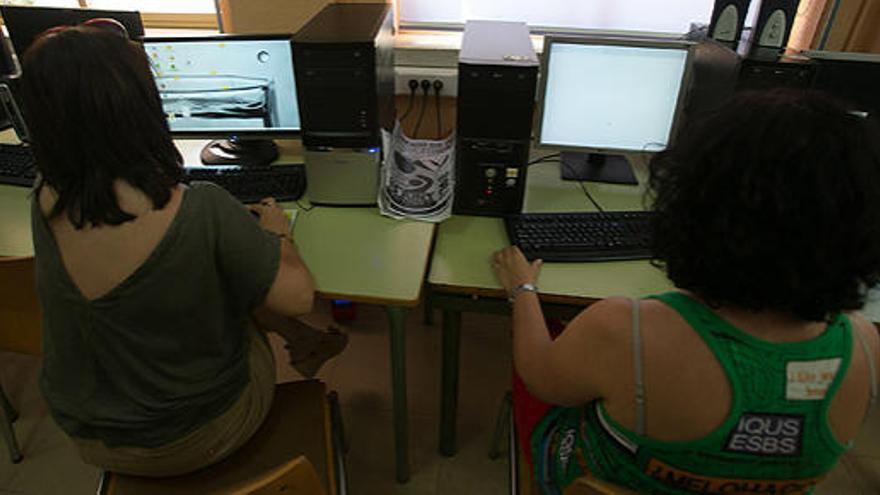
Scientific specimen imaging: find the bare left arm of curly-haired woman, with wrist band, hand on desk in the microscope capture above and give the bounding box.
[493,247,631,406]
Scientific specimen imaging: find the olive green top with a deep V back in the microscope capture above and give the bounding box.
[31,183,280,447]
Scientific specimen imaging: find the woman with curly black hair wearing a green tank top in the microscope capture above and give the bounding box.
[494,92,880,494]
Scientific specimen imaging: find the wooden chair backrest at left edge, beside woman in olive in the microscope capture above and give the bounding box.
[0,256,43,355]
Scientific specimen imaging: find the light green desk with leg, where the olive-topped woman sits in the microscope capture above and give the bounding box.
[0,138,434,483]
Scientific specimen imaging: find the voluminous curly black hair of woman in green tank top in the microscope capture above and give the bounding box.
[649,91,880,321]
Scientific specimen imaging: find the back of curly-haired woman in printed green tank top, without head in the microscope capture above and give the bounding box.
[533,293,878,493]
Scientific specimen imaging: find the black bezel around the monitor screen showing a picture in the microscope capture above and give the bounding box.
[139,33,302,139]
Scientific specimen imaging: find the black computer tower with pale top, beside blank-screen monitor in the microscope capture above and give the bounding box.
[453,21,538,216]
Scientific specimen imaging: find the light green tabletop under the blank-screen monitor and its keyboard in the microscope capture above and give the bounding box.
[428,156,672,303]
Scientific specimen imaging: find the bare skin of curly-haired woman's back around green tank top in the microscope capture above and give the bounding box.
[603,299,878,444]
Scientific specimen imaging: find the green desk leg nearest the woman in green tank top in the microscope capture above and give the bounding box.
[440,309,461,456]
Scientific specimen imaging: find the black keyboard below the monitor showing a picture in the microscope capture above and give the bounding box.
[186,165,306,203]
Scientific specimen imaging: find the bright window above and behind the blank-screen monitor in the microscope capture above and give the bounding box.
[399,0,713,33]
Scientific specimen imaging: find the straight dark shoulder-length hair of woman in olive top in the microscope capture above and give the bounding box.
[21,26,183,228]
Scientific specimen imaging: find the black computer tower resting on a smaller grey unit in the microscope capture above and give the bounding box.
[293,3,394,148]
